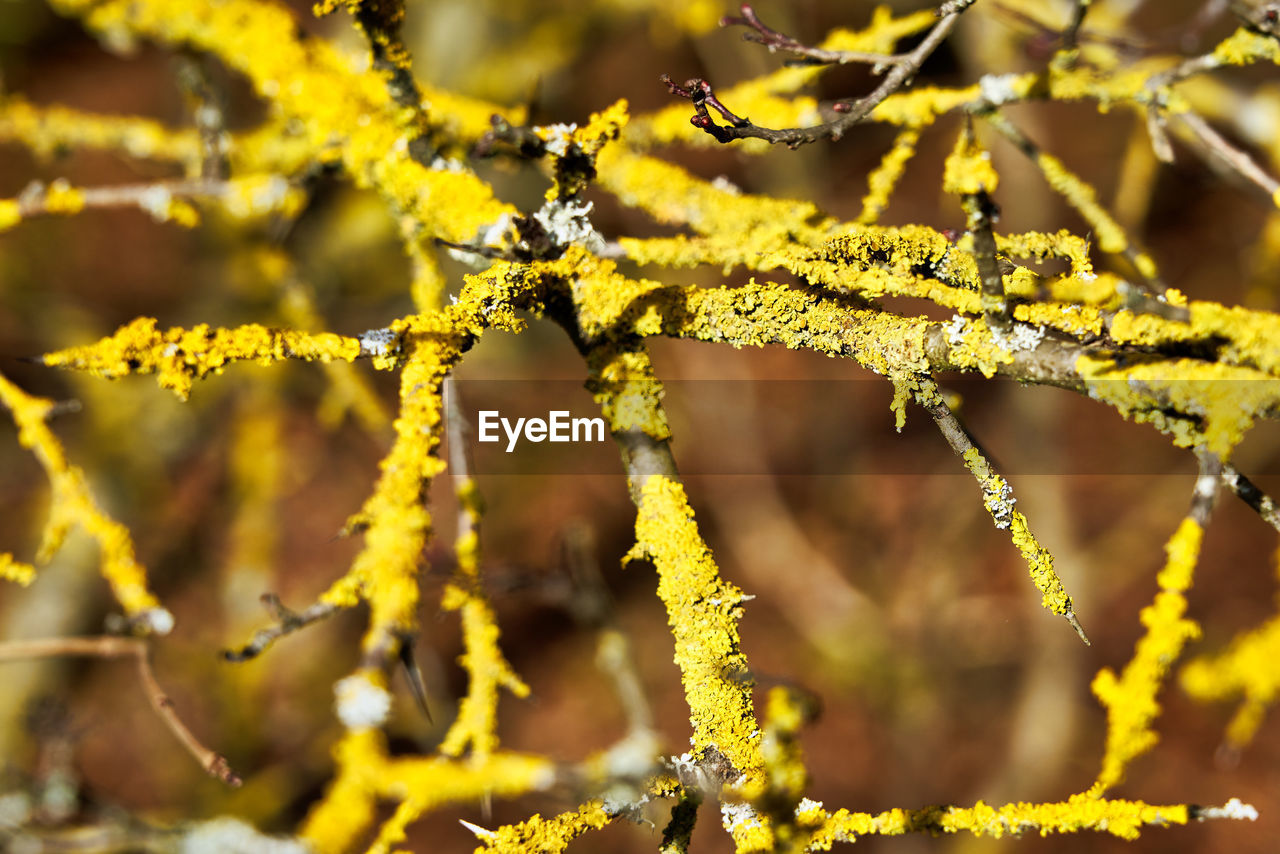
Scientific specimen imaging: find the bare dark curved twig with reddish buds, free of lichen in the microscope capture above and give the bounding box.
[659,0,974,149]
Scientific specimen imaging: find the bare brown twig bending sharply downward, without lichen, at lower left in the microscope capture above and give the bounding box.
[0,635,241,786]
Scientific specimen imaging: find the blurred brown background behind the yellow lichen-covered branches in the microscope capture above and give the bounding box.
[0,0,1280,854]
